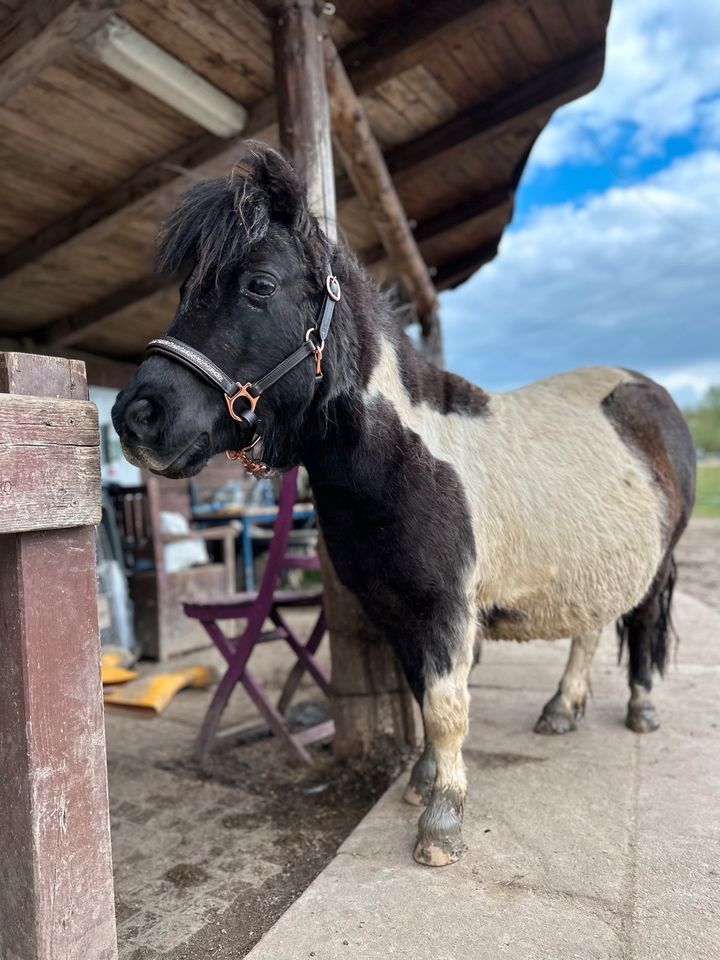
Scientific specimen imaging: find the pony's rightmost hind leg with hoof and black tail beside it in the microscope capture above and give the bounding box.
[618,556,675,733]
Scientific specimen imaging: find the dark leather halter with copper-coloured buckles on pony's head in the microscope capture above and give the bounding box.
[145,274,340,473]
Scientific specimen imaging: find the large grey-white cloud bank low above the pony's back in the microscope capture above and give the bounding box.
[442,150,720,401]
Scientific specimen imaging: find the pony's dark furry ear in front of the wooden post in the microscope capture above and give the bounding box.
[231,140,317,235]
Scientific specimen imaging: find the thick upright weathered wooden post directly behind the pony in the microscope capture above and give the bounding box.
[272,0,421,758]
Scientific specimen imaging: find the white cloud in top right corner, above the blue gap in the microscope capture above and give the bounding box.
[529,0,720,173]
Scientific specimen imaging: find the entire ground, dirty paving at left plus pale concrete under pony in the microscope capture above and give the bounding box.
[106,521,720,960]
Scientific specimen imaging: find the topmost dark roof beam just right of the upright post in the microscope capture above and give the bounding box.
[340,0,530,93]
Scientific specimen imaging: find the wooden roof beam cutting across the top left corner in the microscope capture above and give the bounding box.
[0,0,121,104]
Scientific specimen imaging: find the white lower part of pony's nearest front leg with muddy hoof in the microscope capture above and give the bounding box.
[414,626,475,867]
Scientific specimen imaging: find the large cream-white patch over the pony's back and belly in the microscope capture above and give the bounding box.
[367,340,664,640]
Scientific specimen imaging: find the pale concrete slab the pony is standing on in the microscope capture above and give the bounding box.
[243,594,720,960]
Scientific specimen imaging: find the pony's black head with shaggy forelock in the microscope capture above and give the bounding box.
[112,141,334,478]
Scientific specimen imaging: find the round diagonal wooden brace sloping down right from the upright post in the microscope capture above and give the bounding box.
[324,38,438,335]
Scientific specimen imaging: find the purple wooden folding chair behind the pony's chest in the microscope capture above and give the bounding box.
[183,469,334,764]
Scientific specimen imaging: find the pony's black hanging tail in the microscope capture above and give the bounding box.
[616,554,678,679]
